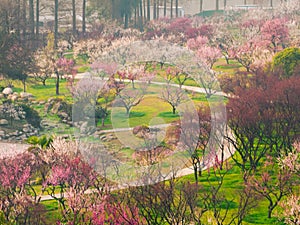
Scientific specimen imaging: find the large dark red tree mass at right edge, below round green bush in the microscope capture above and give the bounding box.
[227,74,300,169]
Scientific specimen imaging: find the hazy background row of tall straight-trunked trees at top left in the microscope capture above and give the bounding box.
[0,0,184,46]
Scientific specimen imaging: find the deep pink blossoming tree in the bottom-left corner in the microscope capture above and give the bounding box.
[0,152,47,224]
